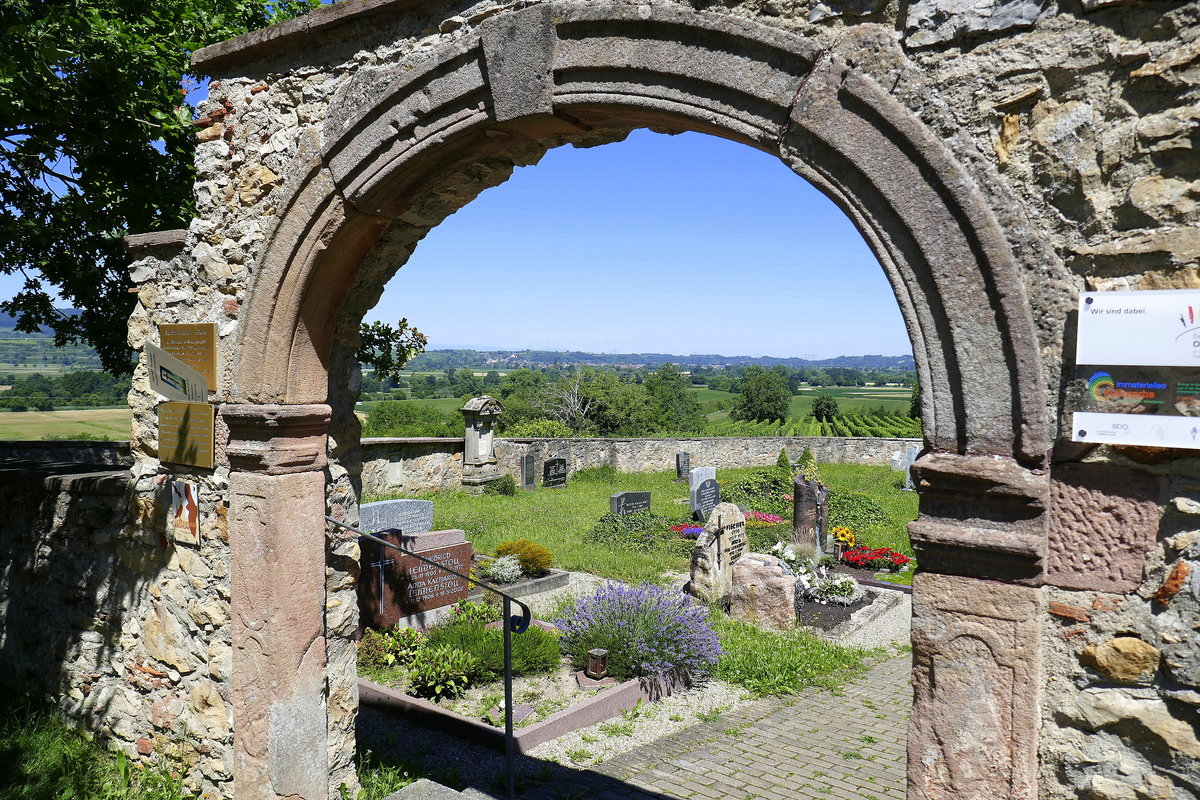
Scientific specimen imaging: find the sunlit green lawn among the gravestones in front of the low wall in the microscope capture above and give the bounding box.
[364,464,917,583]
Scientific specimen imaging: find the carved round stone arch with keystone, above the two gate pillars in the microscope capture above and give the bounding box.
[233,2,1050,465]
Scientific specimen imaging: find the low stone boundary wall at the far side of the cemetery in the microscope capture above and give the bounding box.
[362,437,920,495]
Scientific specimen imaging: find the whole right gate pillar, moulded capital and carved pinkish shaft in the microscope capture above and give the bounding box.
[908,453,1050,800]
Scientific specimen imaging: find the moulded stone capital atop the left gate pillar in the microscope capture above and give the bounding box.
[221,404,332,475]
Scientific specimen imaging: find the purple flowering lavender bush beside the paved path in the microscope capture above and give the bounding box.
[554,583,721,682]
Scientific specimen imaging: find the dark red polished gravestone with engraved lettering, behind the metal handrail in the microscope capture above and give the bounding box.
[359,530,474,628]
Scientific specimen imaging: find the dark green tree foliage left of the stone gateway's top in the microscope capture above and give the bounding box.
[0,0,319,373]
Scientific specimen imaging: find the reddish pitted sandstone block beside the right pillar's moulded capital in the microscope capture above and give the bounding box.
[1045,464,1159,591]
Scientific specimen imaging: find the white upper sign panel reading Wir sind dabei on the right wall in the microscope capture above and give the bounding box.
[1075,289,1200,367]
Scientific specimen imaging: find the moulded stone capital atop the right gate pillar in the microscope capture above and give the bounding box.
[908,452,1050,584]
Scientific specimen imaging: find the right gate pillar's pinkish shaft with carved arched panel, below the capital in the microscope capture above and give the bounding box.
[908,573,1040,800]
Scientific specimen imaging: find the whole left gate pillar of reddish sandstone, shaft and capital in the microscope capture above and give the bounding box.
[221,405,330,800]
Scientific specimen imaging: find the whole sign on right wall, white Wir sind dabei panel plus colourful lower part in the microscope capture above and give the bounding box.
[1072,289,1200,450]
